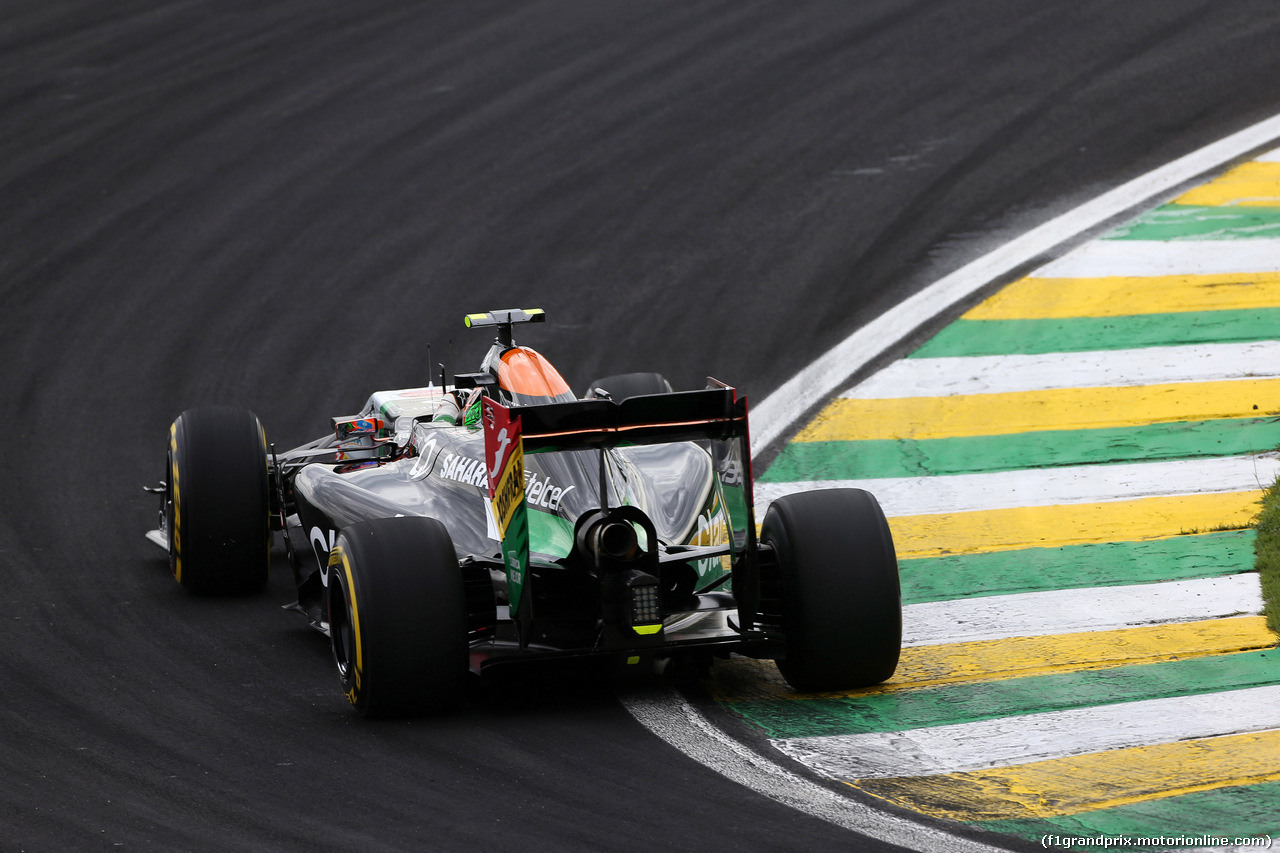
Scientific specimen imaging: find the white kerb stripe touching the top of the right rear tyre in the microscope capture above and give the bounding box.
[755,452,1280,520]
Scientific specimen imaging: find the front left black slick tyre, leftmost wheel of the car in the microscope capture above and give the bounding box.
[165,406,271,594]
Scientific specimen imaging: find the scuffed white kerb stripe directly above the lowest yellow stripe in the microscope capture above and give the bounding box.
[772,686,1280,779]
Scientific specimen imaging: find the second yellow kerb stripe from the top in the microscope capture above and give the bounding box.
[964,273,1280,320]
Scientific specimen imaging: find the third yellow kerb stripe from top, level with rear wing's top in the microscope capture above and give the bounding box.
[795,379,1280,442]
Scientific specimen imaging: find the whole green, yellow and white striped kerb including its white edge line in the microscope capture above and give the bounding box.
[623,111,1280,850]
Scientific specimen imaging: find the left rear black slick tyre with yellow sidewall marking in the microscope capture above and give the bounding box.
[329,517,468,717]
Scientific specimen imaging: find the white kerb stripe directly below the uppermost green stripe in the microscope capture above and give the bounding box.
[1032,237,1280,278]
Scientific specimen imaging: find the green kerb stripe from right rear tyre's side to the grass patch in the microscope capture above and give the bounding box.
[899,530,1256,605]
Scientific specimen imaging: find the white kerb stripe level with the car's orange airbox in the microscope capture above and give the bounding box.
[841,343,1280,400]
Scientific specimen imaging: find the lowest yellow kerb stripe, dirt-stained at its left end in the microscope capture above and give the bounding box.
[849,711,1280,821]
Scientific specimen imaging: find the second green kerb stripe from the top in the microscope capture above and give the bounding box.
[909,307,1280,359]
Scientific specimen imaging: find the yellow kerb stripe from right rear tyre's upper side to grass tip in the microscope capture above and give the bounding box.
[888,491,1262,560]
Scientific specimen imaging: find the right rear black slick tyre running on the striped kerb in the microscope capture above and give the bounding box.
[760,489,902,690]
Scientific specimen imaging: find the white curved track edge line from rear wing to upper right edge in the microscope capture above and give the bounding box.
[751,115,1280,455]
